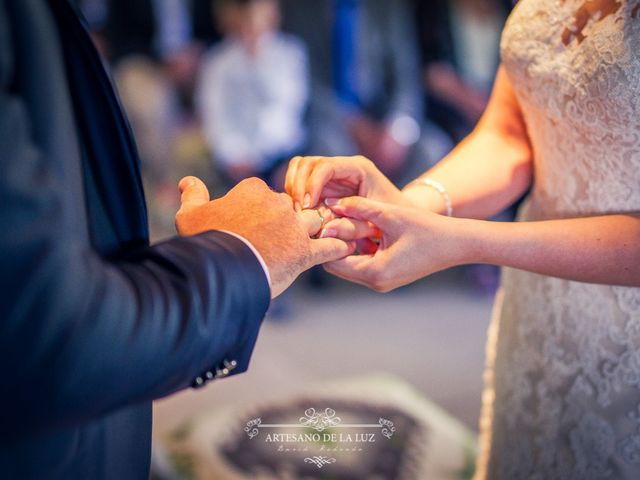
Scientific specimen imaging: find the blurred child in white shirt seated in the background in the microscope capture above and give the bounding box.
[195,0,309,189]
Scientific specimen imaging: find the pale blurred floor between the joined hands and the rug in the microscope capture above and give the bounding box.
[154,270,493,435]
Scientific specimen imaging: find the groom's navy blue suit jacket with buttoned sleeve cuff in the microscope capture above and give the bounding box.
[0,0,270,479]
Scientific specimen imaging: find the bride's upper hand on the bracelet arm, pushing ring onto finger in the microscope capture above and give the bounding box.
[284,156,409,211]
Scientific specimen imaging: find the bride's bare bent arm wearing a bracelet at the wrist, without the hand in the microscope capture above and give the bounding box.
[403,67,532,218]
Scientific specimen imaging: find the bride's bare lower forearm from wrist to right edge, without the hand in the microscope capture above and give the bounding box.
[467,214,640,287]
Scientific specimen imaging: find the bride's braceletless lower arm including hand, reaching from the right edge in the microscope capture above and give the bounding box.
[325,197,640,291]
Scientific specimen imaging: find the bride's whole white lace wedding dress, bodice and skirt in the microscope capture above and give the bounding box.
[476,0,640,480]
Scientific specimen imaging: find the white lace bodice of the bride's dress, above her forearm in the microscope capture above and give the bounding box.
[502,0,640,217]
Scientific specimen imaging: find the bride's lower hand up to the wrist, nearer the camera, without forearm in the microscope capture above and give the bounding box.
[323,197,470,292]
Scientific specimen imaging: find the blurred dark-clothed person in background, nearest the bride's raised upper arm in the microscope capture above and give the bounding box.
[416,0,511,142]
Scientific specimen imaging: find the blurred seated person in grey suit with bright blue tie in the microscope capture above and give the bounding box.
[282,0,446,183]
